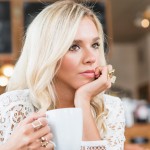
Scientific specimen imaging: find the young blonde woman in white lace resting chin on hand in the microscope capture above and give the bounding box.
[0,1,125,150]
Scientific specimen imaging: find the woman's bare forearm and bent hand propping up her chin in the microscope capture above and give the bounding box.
[74,66,111,141]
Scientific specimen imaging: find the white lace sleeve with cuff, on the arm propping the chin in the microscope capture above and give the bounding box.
[81,96,125,150]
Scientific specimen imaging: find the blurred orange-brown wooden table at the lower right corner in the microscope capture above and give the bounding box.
[125,123,150,149]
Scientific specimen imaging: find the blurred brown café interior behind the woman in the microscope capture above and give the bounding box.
[0,0,150,150]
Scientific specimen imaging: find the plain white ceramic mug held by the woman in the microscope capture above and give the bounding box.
[46,108,83,150]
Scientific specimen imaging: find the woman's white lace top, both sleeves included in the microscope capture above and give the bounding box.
[0,89,125,150]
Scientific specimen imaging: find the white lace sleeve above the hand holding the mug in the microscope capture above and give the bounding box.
[0,92,34,144]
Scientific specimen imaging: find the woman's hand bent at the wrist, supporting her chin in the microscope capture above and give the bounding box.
[74,65,112,106]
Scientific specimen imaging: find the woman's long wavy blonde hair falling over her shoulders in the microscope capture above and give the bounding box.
[7,0,107,136]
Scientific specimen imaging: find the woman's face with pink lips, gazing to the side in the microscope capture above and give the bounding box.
[55,17,101,90]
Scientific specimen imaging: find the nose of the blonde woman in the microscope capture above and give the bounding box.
[83,50,96,64]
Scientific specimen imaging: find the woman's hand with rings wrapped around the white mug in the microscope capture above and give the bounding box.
[3,113,54,150]
